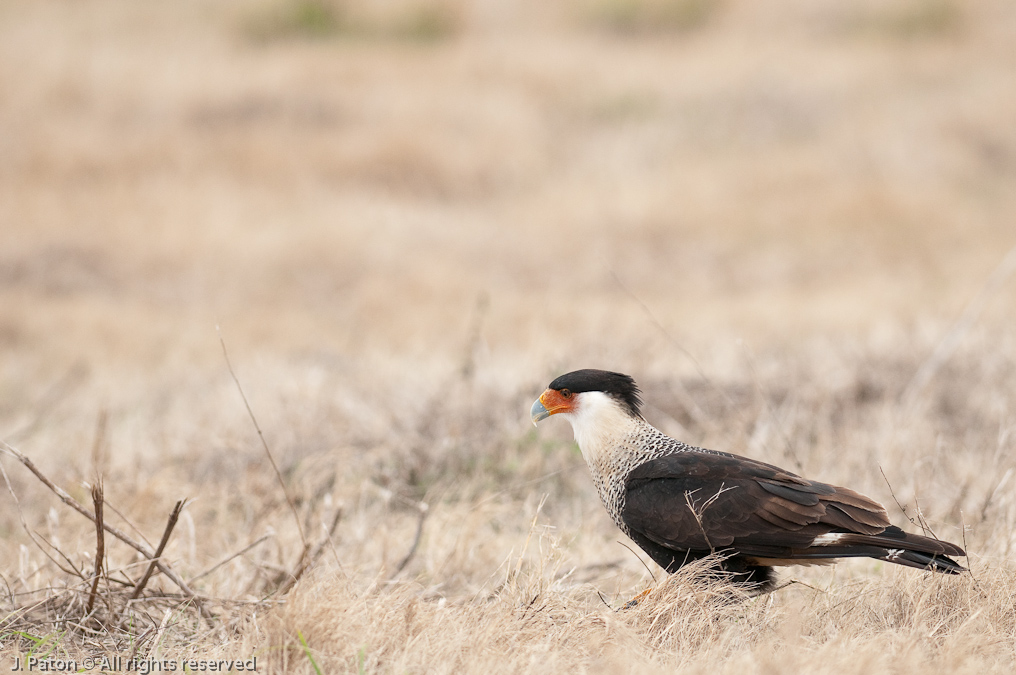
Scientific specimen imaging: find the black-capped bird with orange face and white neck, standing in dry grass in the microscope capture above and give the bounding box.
[530,369,966,592]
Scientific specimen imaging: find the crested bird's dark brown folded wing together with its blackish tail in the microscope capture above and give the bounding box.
[620,450,965,573]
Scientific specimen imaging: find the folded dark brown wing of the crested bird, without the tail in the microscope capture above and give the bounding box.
[621,451,889,558]
